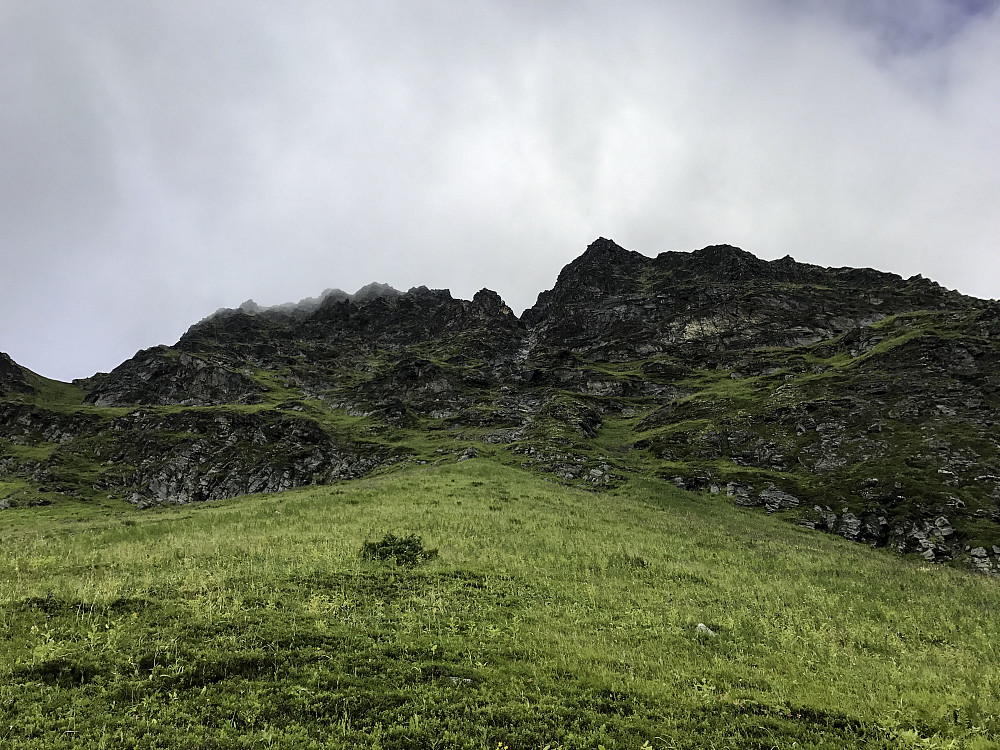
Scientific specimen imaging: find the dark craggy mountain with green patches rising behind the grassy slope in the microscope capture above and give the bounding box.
[0,238,1000,575]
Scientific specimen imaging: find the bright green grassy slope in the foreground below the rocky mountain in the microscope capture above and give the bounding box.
[0,458,1000,750]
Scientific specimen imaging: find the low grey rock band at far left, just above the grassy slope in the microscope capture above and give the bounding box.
[0,405,392,507]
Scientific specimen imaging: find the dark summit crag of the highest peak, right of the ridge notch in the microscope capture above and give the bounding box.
[522,238,961,361]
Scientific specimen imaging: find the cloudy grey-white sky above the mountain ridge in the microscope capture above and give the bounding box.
[0,0,1000,380]
